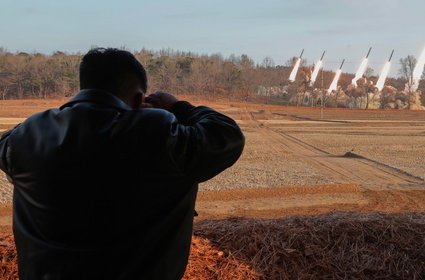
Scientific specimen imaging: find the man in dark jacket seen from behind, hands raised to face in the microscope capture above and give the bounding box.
[0,48,244,280]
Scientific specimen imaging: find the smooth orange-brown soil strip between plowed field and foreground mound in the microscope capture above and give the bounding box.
[196,185,425,220]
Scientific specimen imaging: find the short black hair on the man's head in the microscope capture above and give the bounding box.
[80,48,147,93]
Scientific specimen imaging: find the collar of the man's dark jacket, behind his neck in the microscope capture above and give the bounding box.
[60,89,131,110]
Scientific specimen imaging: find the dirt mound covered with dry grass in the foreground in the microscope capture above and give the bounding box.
[0,212,425,280]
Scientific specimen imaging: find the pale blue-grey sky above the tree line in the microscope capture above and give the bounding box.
[0,0,425,76]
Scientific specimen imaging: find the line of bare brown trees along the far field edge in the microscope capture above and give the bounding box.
[0,47,425,106]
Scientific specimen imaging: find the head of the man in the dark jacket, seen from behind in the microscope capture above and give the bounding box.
[80,48,147,107]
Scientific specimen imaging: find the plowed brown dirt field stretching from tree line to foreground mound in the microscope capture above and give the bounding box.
[0,97,425,231]
